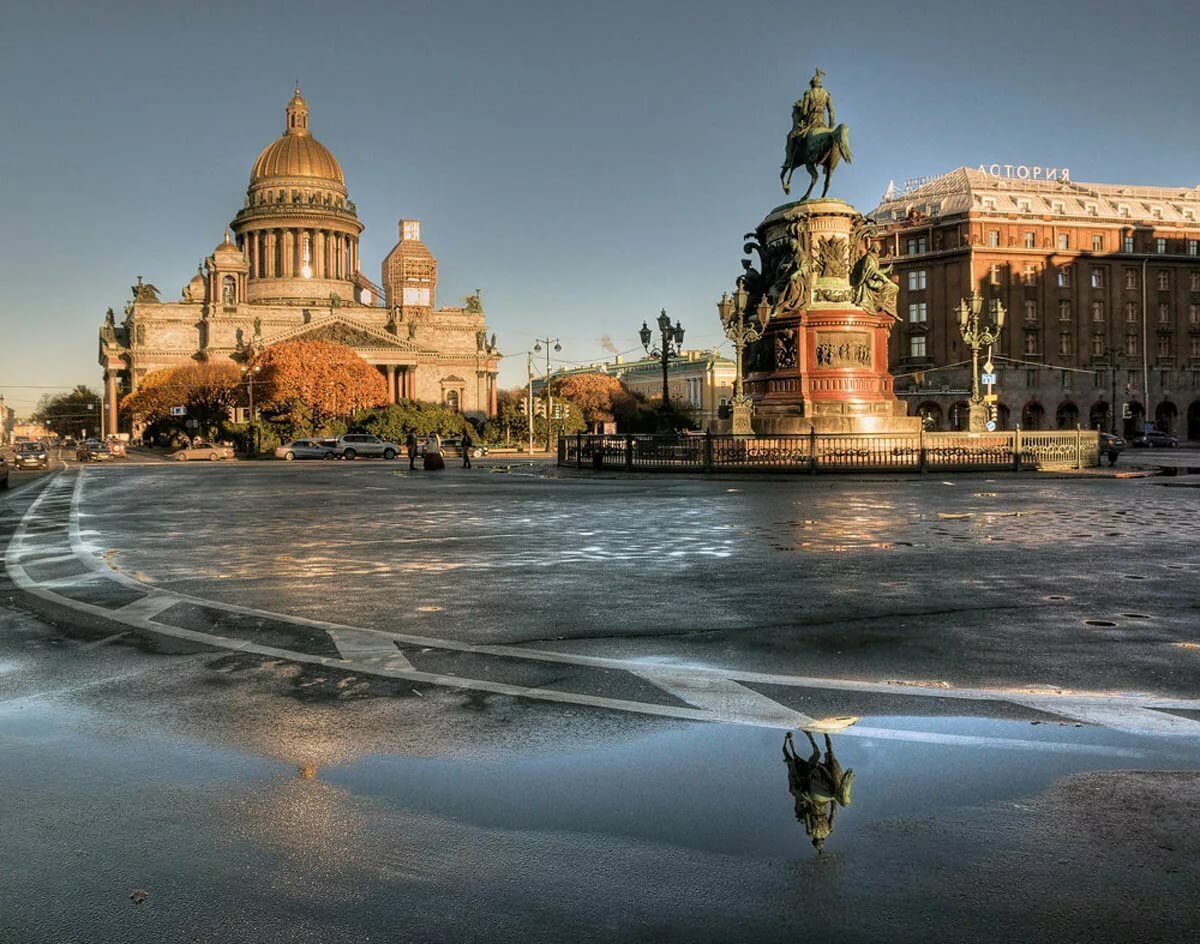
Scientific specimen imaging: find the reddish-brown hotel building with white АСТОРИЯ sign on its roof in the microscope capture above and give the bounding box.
[871,166,1200,439]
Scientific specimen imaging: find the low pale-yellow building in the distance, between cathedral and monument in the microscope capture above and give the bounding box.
[533,350,736,428]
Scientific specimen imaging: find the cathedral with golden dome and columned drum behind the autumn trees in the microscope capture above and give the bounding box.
[100,89,499,431]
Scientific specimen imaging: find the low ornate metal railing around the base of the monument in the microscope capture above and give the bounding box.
[558,428,1100,473]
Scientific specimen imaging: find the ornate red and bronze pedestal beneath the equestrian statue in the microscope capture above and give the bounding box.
[743,199,920,435]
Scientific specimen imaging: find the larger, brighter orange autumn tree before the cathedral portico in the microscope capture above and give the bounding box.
[254,341,388,431]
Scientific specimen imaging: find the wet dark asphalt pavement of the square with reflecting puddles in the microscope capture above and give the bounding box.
[0,463,1200,943]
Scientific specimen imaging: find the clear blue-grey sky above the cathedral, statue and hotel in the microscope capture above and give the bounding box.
[0,0,1200,413]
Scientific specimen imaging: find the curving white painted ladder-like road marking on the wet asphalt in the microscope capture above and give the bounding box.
[5,473,1200,753]
